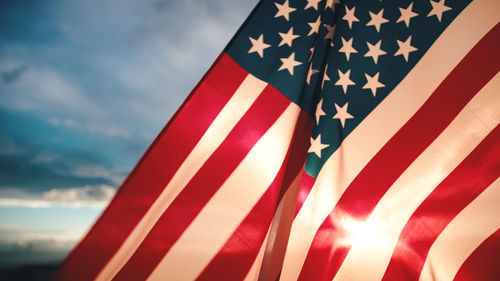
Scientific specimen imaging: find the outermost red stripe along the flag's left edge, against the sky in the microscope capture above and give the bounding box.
[55,53,248,281]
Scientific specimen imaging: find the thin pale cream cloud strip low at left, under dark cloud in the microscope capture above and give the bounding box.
[0,185,115,208]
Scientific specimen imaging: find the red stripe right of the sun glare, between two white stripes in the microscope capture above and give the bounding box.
[382,126,500,281]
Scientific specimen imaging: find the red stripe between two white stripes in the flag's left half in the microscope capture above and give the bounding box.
[114,86,290,280]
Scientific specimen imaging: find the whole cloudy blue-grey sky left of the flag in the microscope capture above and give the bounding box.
[0,0,257,267]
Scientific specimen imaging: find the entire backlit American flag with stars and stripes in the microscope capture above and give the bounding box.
[57,0,500,281]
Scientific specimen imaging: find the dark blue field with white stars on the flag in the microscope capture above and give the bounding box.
[228,0,466,176]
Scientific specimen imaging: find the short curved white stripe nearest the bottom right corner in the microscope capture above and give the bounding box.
[420,179,500,281]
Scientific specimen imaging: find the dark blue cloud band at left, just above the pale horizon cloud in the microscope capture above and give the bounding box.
[0,129,128,193]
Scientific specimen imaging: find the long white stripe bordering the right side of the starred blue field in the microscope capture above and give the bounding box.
[281,0,500,280]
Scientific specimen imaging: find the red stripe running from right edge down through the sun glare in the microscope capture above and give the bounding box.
[299,25,500,281]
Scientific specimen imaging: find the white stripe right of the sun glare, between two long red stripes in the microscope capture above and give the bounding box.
[334,71,500,281]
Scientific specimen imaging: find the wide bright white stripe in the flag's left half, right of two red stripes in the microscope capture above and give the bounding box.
[148,103,300,280]
